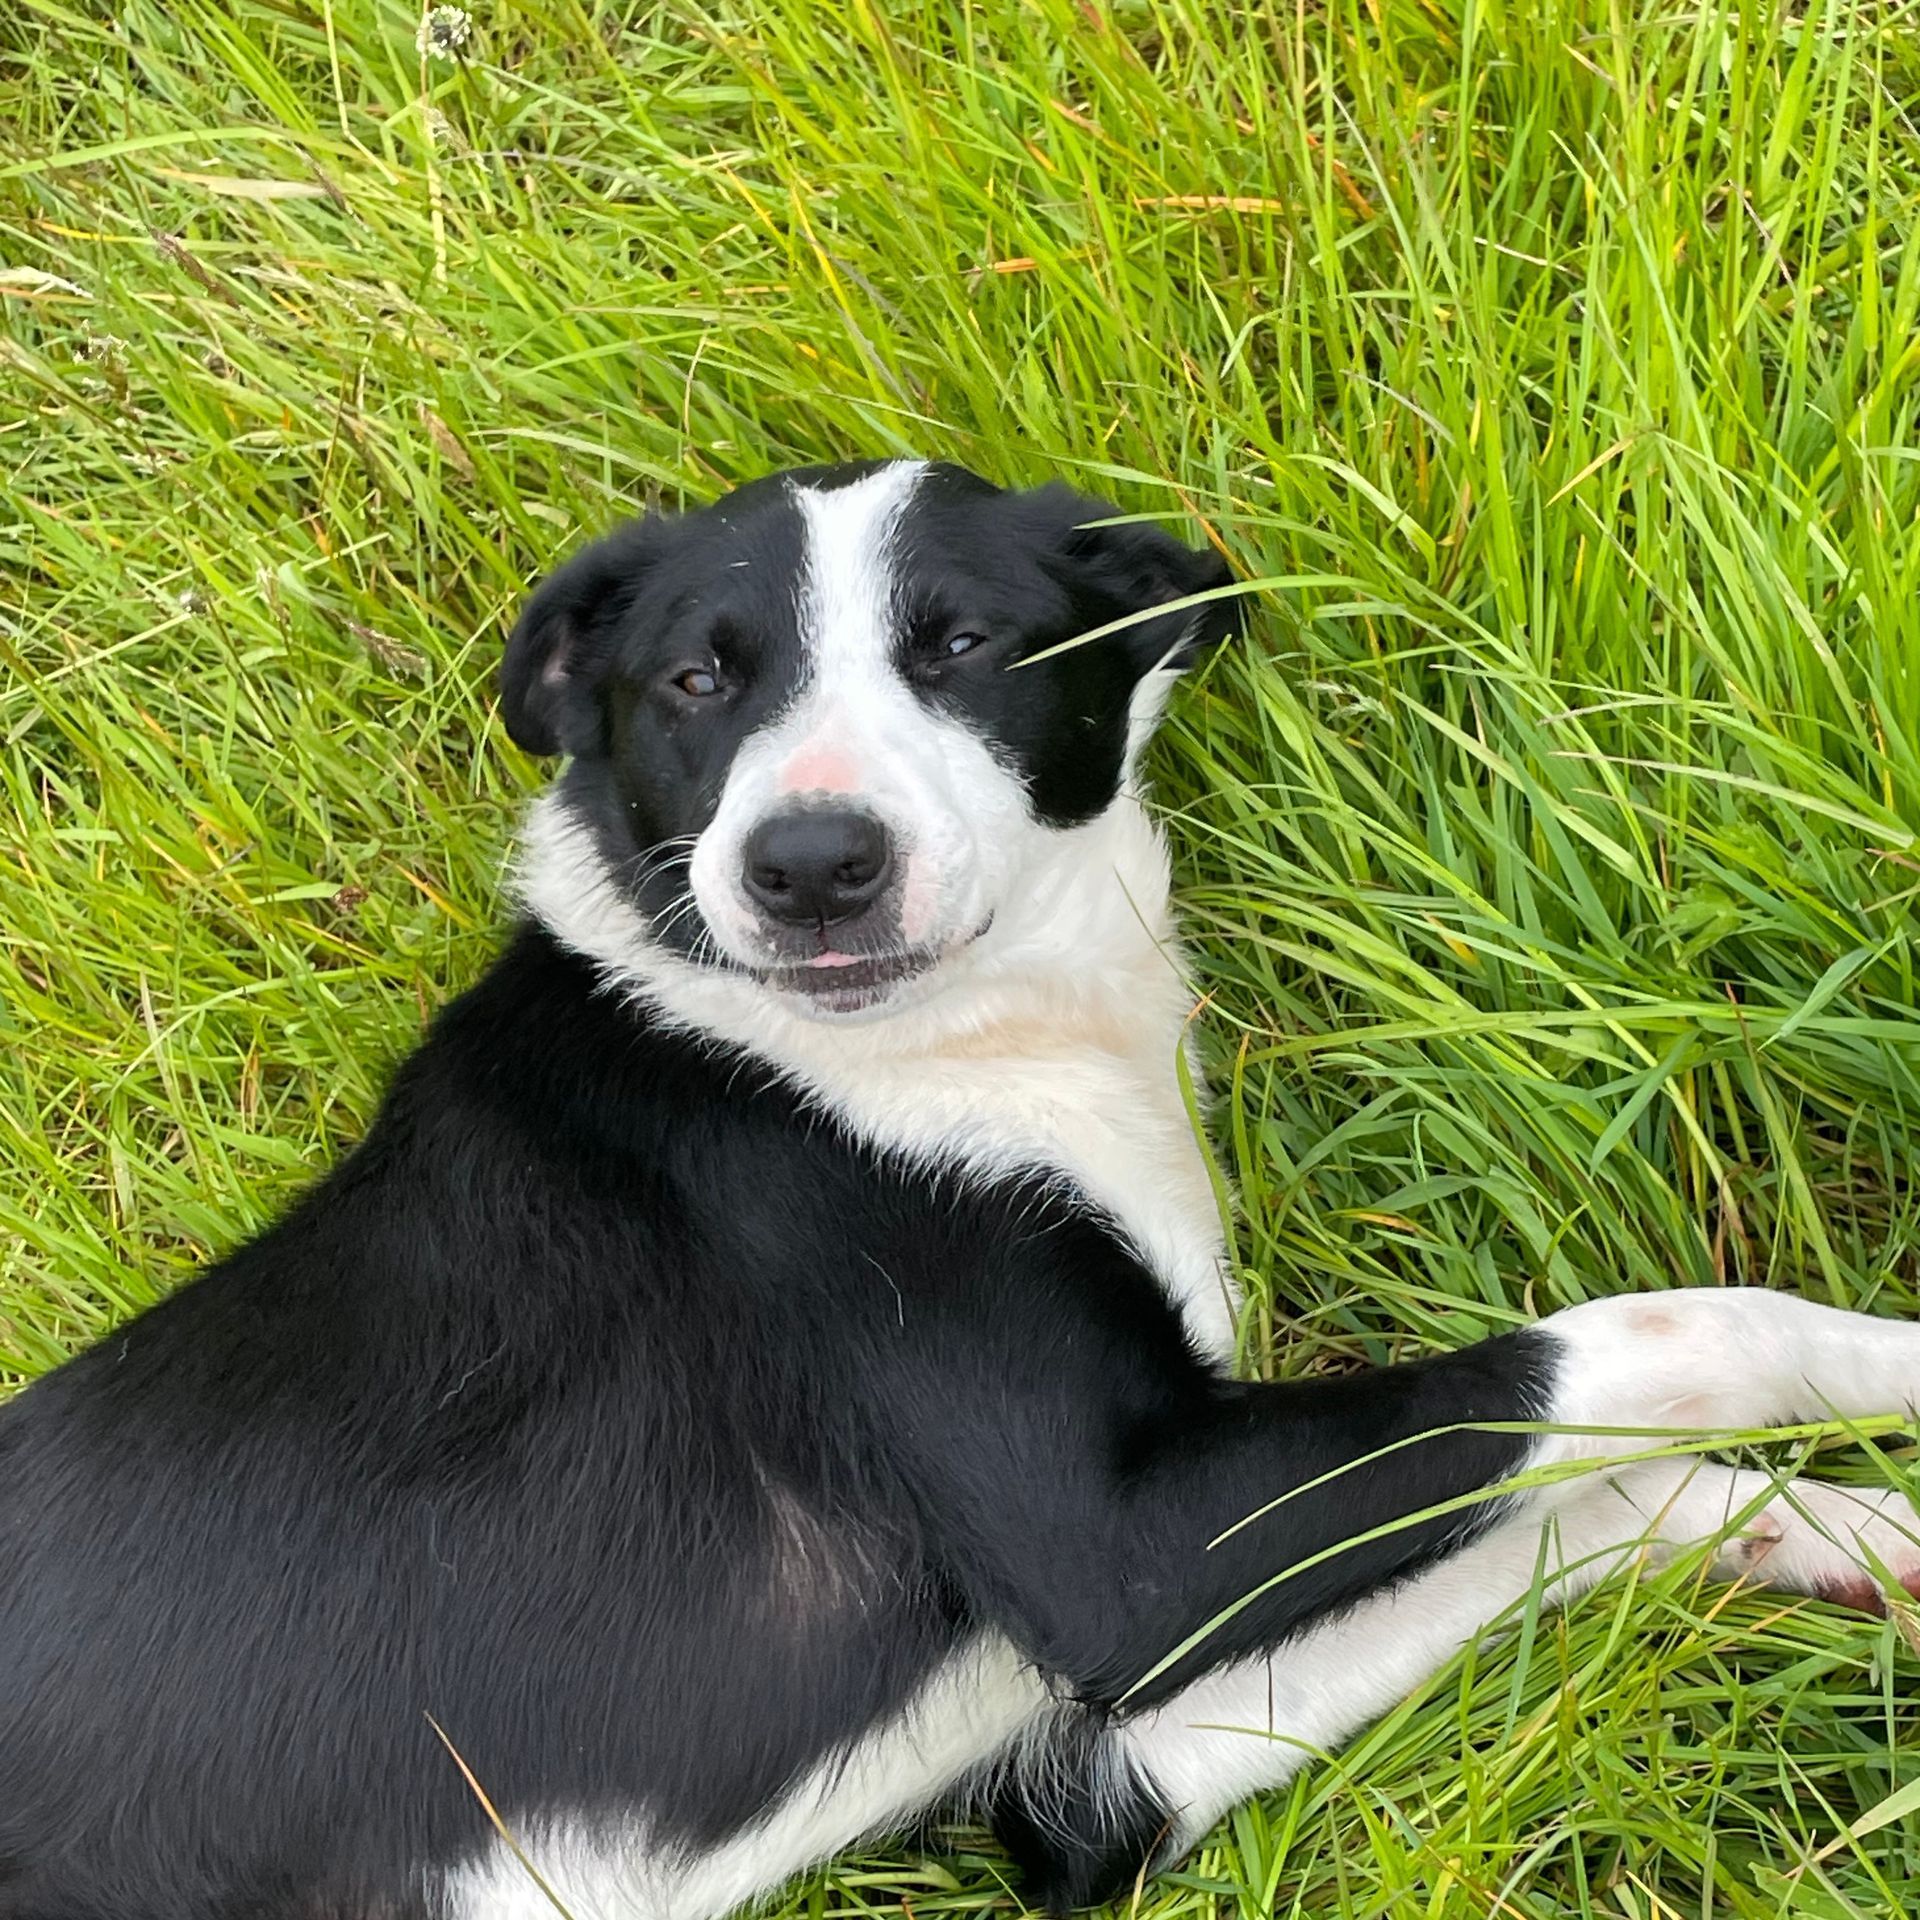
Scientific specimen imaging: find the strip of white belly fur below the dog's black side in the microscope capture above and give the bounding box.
[440,1640,1046,1920]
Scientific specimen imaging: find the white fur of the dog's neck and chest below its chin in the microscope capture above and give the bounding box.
[522,789,1235,1365]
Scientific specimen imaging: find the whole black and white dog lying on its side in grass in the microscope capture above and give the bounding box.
[0,461,1920,1920]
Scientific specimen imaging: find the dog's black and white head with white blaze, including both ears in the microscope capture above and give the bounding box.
[501,461,1233,1012]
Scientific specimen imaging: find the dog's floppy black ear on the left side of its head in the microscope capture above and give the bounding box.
[499,518,674,753]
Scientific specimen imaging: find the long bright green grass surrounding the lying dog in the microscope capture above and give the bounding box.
[0,0,1920,1920]
